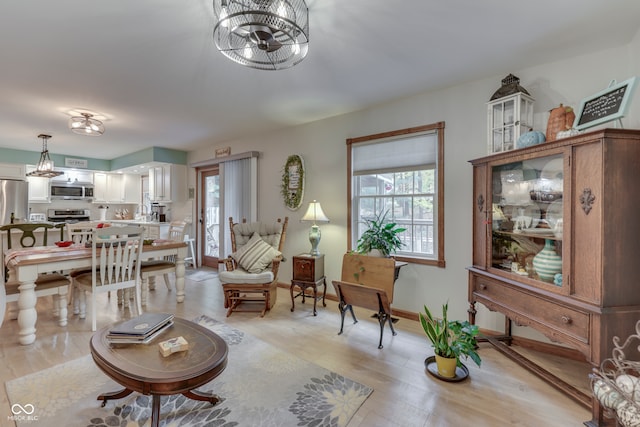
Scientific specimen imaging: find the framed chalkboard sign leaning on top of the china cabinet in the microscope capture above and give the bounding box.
[573,77,637,130]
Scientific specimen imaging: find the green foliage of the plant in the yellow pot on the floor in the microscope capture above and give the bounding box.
[419,303,481,366]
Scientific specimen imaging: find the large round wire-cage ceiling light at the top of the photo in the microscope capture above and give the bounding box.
[213,0,309,70]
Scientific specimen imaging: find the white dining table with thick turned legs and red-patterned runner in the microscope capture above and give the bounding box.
[3,241,187,345]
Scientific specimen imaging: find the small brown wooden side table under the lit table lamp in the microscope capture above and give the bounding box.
[290,254,327,316]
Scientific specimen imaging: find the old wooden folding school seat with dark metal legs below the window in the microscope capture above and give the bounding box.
[333,254,396,348]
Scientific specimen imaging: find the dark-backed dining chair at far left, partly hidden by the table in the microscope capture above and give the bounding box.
[0,223,69,326]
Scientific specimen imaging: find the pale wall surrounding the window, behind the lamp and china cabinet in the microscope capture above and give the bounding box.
[189,33,640,336]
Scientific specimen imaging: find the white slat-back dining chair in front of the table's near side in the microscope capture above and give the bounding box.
[75,226,144,331]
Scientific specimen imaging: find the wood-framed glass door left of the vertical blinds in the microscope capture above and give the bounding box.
[198,166,220,268]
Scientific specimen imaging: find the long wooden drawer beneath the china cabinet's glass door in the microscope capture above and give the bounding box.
[473,277,589,342]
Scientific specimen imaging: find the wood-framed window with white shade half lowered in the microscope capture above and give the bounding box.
[347,122,444,266]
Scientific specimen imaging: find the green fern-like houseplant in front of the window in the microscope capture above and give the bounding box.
[356,211,407,257]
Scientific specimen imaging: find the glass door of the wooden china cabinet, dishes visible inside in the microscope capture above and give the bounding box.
[491,154,564,287]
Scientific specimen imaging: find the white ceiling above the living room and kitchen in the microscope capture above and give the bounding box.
[0,0,640,159]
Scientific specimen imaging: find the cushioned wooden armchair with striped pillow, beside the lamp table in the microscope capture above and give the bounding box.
[218,217,289,317]
